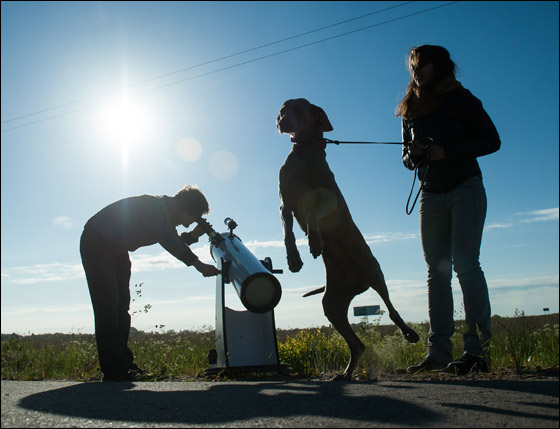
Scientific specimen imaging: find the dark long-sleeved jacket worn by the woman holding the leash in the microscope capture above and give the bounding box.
[402,87,501,193]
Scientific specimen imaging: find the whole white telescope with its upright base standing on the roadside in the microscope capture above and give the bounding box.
[197,218,282,375]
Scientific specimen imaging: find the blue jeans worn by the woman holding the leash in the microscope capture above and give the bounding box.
[420,176,491,364]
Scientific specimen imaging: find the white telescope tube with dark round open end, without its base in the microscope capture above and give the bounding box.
[210,232,282,313]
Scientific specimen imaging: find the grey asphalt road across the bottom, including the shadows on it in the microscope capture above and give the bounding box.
[2,376,559,428]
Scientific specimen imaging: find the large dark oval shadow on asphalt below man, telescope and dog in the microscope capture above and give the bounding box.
[19,382,440,426]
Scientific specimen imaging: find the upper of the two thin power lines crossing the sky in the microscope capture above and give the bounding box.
[2,1,414,124]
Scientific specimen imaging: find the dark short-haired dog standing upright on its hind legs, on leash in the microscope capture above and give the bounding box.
[276,98,419,380]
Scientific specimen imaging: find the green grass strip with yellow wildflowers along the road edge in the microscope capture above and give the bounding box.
[2,310,559,381]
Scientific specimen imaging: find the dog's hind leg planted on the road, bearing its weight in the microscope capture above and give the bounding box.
[323,277,365,381]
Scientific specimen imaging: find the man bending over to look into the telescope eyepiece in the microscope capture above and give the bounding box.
[80,186,219,381]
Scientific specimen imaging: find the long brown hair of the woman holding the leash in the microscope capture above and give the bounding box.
[395,45,457,116]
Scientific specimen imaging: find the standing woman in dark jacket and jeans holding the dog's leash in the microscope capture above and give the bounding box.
[396,45,500,374]
